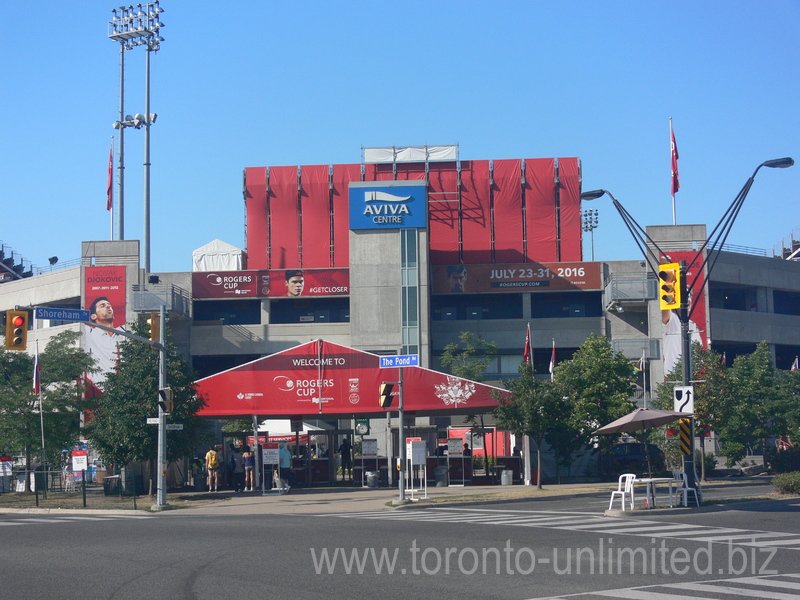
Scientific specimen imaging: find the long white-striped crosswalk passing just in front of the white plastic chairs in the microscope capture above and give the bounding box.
[319,508,800,550]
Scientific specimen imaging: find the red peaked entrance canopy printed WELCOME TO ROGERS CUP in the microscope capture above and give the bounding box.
[196,340,505,418]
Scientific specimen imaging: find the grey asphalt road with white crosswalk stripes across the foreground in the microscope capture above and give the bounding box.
[0,486,800,600]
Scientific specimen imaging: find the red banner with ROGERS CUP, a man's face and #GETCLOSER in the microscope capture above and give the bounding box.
[192,269,350,299]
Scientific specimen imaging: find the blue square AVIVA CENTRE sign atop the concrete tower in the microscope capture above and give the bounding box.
[350,181,428,229]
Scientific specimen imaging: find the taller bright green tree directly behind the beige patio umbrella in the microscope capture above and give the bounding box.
[553,333,636,470]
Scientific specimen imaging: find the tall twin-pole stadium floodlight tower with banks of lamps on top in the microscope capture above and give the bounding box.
[108,0,164,273]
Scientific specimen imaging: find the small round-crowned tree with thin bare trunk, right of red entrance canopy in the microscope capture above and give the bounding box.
[492,363,569,489]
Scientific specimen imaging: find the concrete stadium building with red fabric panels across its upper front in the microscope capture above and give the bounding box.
[0,146,800,486]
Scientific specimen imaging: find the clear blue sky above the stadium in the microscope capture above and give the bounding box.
[0,0,800,272]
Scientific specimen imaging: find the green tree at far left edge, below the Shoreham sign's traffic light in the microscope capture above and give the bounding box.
[0,331,94,488]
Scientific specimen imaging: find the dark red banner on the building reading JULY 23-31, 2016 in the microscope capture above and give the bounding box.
[432,262,602,294]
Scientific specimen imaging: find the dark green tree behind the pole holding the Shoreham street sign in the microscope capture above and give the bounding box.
[86,320,210,490]
